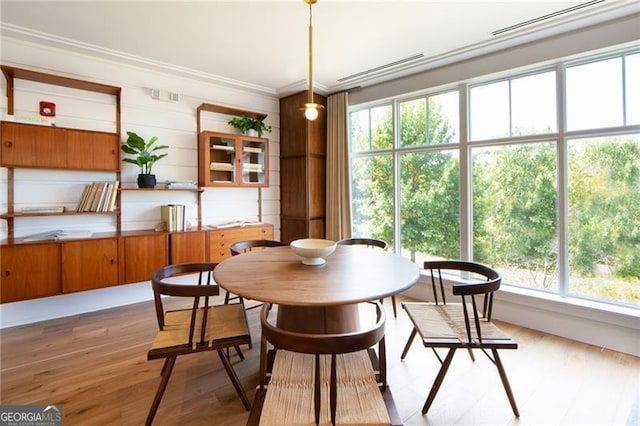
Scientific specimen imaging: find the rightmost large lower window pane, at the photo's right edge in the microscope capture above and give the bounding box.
[568,134,640,303]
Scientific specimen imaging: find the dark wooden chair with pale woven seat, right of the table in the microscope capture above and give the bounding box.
[400,260,520,417]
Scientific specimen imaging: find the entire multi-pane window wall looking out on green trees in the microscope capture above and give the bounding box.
[350,51,640,306]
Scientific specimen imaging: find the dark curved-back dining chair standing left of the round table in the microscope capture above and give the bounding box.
[145,263,251,425]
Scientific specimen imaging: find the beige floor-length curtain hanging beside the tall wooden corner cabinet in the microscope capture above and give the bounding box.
[326,92,351,241]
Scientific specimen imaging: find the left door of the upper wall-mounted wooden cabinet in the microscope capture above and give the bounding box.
[0,122,67,168]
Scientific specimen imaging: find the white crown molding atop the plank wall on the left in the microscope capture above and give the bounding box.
[0,22,278,96]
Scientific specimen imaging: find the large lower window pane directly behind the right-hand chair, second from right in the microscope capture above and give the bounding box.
[471,142,558,291]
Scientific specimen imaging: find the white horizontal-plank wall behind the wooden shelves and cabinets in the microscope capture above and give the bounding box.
[0,37,280,327]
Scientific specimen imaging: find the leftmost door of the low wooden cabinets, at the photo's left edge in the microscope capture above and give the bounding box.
[0,243,61,303]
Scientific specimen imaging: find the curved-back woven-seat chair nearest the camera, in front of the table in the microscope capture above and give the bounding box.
[248,302,396,424]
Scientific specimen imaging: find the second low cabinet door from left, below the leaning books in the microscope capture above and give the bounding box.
[61,238,118,293]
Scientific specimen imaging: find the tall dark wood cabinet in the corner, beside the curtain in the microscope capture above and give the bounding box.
[280,92,327,243]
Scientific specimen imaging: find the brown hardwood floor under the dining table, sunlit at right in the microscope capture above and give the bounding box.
[0,292,640,426]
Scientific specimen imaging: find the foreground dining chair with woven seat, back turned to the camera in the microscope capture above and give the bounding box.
[247,302,401,425]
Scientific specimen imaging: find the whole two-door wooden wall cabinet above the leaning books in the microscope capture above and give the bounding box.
[0,121,120,171]
